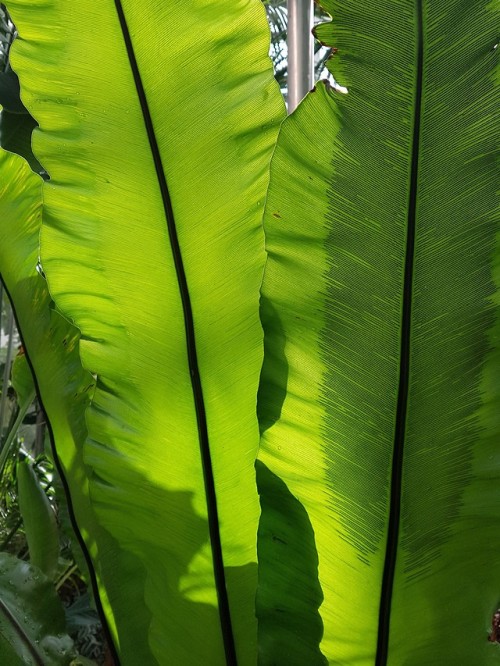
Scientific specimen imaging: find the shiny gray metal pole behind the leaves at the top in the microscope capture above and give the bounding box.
[287,0,314,113]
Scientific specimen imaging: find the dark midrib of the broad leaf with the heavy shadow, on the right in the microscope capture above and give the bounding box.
[375,0,424,666]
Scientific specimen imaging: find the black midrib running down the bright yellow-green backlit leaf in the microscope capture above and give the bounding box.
[115,0,237,666]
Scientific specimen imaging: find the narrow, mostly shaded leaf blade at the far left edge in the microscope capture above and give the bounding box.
[0,151,154,663]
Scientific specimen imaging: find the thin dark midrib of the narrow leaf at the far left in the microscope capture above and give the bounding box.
[0,274,120,666]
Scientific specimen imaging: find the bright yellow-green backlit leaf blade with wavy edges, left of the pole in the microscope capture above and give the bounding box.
[4,0,283,666]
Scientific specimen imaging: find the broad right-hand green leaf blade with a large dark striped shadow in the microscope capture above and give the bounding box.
[257,1,500,666]
